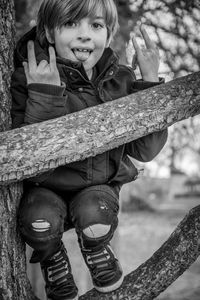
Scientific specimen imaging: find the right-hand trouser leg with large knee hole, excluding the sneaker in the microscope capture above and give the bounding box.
[70,185,119,248]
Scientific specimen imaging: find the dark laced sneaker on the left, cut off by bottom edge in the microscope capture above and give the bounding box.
[41,243,78,300]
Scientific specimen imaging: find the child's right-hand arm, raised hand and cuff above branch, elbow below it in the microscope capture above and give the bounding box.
[125,26,168,162]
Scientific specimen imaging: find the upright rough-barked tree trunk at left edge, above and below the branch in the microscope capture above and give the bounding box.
[0,0,36,300]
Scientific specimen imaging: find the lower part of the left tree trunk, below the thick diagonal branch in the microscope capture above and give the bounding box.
[0,183,36,300]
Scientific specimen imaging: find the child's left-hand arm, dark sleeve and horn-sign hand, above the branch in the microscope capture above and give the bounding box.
[11,43,67,128]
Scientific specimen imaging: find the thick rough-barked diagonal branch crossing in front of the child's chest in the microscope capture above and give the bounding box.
[0,72,200,184]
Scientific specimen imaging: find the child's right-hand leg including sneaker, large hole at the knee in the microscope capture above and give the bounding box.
[70,185,123,292]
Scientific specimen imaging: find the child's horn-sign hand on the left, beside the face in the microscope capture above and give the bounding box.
[23,41,60,85]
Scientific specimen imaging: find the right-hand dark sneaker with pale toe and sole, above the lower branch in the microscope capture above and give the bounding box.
[82,244,124,293]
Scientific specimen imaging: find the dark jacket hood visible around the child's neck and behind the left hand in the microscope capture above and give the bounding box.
[14,27,118,79]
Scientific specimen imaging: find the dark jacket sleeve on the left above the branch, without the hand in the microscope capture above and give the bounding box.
[11,68,67,128]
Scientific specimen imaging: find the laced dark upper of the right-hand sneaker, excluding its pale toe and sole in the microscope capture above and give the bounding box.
[86,246,115,281]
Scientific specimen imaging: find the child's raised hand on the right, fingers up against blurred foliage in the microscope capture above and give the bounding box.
[132,25,160,82]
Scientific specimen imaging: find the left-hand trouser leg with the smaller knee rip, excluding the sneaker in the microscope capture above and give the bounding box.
[18,187,67,262]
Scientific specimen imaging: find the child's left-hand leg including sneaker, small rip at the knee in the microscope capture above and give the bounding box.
[19,187,78,300]
